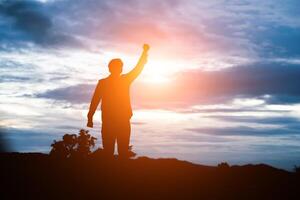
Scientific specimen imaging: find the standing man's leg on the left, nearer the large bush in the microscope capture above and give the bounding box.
[101,120,116,156]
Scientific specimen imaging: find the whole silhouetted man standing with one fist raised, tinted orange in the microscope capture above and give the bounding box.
[87,44,149,158]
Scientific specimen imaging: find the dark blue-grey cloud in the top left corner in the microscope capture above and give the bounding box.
[0,0,80,46]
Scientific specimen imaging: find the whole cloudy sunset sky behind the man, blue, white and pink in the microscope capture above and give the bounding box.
[0,0,300,169]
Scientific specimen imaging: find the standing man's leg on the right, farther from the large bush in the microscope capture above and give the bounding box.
[117,119,131,158]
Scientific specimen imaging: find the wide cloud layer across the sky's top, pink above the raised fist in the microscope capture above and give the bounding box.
[0,0,300,62]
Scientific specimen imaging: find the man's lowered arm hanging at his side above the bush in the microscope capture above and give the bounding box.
[87,81,102,128]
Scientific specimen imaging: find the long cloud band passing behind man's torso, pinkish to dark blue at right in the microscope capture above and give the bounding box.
[36,63,300,108]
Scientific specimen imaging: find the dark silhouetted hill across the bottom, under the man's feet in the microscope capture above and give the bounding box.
[0,153,300,199]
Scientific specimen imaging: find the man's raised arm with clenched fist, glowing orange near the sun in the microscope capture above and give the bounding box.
[125,44,150,82]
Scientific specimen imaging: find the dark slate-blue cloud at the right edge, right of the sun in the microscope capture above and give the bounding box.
[185,62,300,96]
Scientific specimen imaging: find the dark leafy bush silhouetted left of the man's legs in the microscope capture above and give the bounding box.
[50,129,96,158]
